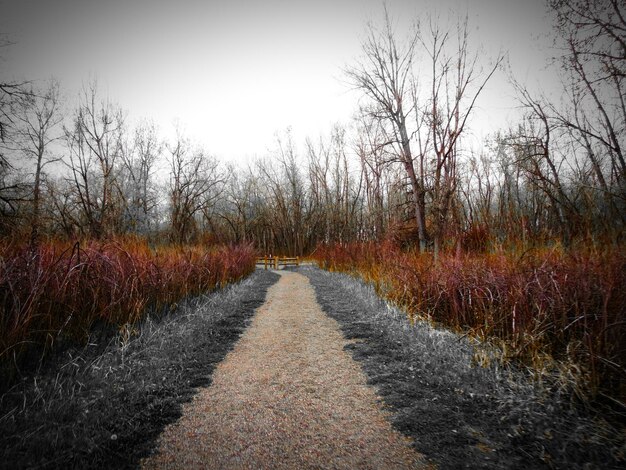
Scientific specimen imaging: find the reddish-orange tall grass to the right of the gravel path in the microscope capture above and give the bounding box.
[315,243,626,406]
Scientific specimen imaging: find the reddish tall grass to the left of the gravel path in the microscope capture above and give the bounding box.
[0,238,255,385]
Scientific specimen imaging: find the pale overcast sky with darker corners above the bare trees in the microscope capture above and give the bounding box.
[0,0,549,160]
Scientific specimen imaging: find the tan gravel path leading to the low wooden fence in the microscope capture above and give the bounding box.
[142,271,424,469]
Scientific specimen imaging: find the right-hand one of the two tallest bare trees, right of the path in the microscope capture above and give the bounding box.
[413,17,503,256]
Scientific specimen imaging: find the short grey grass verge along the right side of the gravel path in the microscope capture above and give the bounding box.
[300,268,626,469]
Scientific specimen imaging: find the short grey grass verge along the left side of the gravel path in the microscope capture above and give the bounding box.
[0,271,278,469]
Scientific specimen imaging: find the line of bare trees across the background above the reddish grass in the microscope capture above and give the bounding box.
[0,0,626,255]
